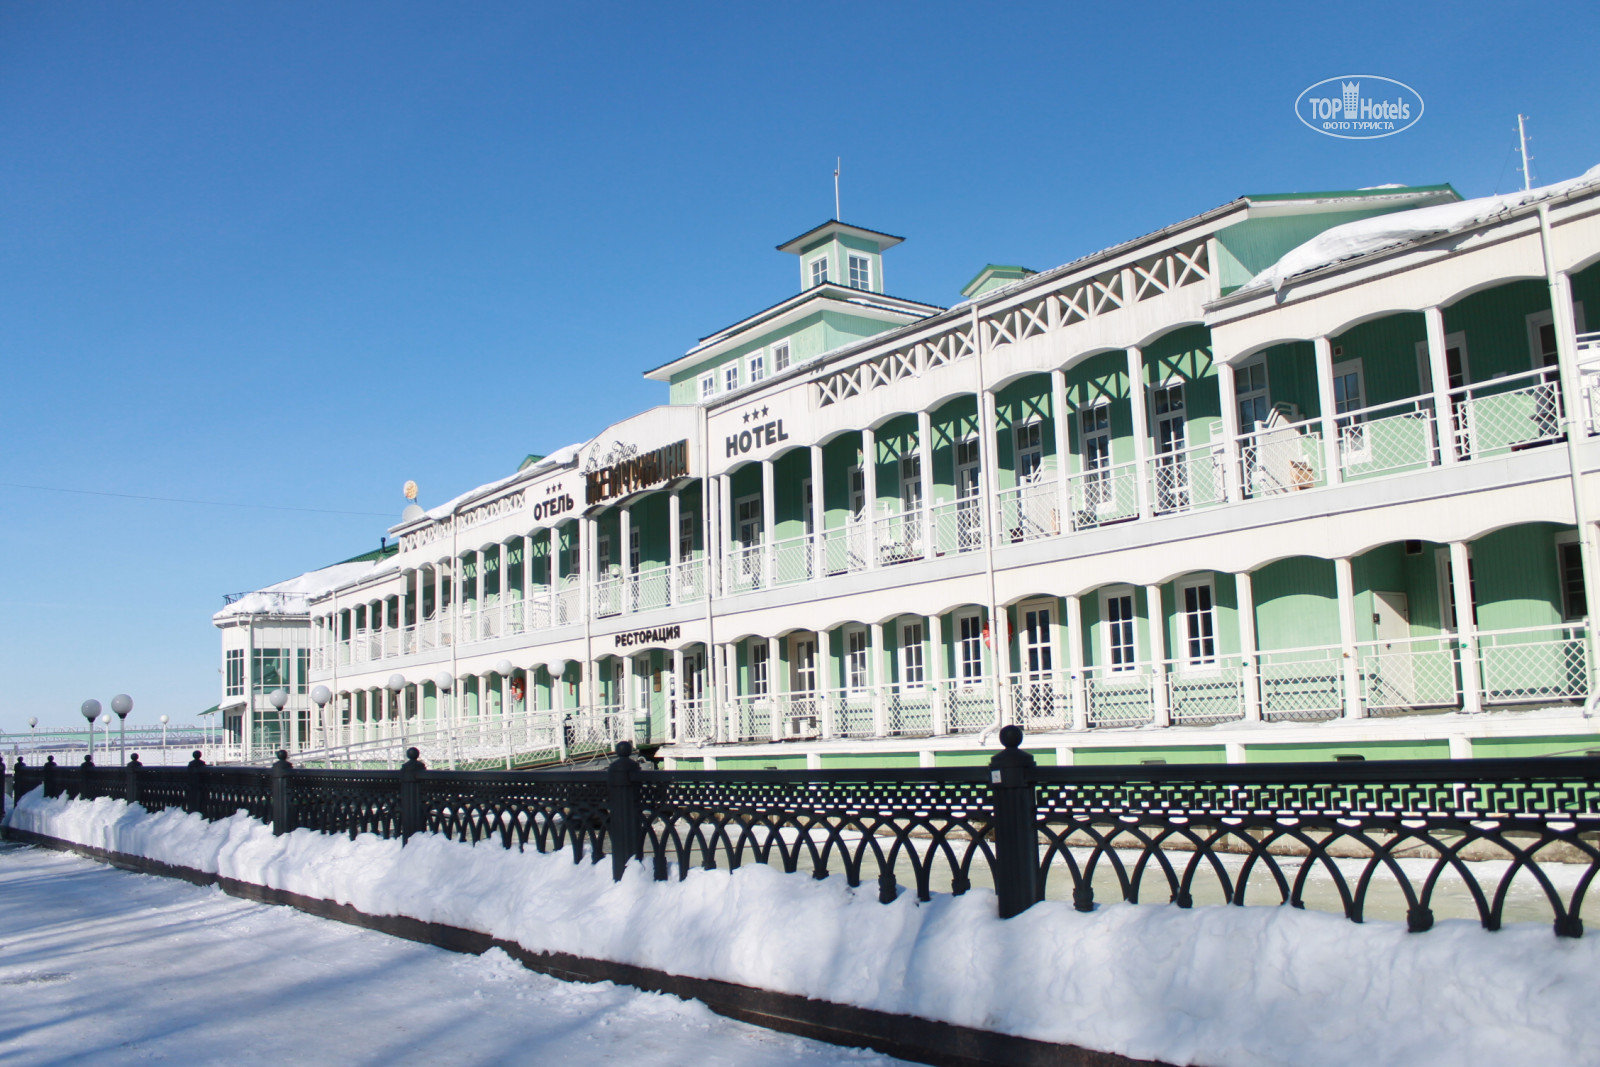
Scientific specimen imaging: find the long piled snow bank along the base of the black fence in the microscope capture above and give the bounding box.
[8,789,1600,1067]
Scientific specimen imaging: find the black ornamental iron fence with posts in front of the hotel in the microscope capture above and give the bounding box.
[0,726,1600,937]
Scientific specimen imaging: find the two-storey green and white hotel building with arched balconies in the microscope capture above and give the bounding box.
[216,168,1600,768]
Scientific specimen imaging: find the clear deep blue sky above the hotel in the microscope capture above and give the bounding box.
[0,0,1600,729]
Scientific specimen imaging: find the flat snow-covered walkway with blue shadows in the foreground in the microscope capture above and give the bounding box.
[0,845,901,1067]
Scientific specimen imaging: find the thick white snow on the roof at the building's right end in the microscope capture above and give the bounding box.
[1238,166,1600,293]
